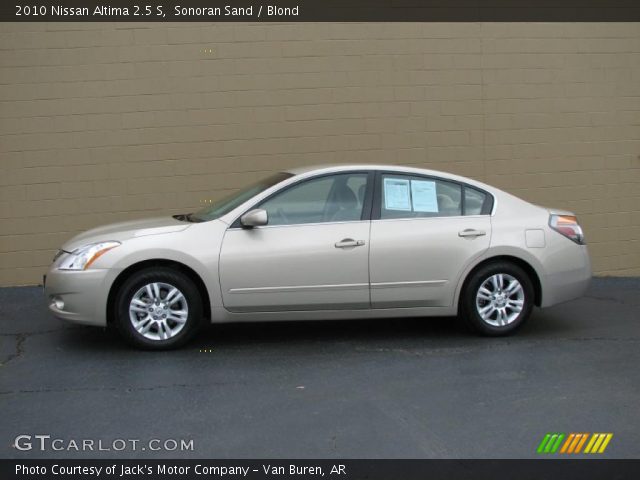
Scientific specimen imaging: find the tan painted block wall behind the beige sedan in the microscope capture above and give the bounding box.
[0,23,640,285]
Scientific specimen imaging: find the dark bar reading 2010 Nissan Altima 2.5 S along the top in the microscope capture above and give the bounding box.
[0,0,640,22]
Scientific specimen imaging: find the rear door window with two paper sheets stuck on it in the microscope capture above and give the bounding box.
[380,174,462,219]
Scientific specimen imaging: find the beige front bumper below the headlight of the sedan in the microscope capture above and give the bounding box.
[44,268,109,326]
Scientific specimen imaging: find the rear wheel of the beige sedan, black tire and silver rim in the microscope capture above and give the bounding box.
[461,262,534,336]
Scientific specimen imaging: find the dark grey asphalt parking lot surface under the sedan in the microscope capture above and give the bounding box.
[0,278,640,459]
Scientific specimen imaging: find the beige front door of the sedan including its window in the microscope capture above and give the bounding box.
[219,171,373,312]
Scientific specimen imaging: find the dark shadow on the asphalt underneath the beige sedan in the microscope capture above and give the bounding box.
[56,310,576,352]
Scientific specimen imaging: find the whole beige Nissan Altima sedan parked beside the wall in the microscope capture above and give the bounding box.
[45,165,591,349]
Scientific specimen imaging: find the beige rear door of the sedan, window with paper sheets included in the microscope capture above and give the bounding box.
[369,173,493,308]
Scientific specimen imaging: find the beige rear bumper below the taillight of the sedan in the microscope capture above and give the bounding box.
[541,245,592,307]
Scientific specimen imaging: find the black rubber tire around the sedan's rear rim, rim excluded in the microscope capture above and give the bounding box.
[460,261,534,337]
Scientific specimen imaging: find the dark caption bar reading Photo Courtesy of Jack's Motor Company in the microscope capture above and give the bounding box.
[0,459,640,480]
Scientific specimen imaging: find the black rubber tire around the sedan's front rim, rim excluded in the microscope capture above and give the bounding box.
[114,267,203,350]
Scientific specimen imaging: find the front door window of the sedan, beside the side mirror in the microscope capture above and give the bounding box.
[257,173,367,225]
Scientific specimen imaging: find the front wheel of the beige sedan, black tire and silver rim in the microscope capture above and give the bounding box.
[116,268,202,350]
